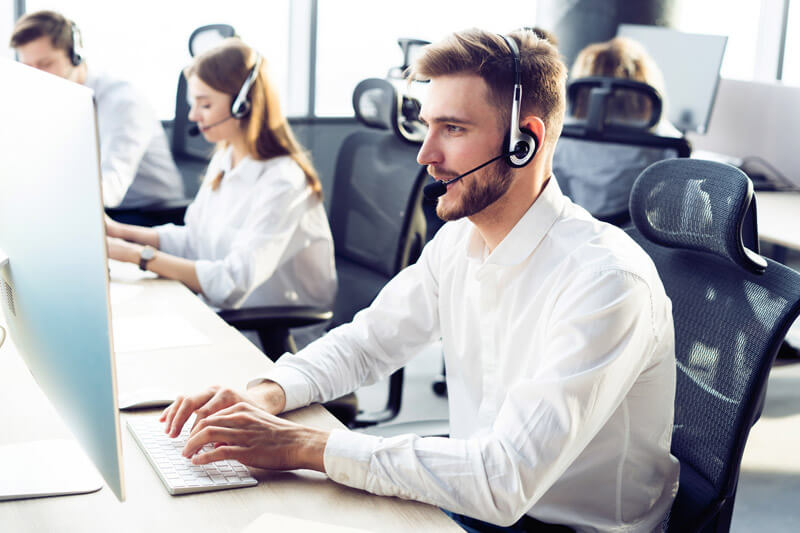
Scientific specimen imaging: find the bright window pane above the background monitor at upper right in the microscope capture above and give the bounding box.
[675,0,761,80]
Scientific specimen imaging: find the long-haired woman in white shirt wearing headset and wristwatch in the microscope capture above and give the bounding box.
[106,39,336,324]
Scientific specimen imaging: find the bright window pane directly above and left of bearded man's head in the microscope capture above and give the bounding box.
[315,0,536,116]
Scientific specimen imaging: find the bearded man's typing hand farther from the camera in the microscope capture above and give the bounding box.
[159,381,286,437]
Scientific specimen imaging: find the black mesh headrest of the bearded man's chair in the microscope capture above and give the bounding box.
[630,159,767,272]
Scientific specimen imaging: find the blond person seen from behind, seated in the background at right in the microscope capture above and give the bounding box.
[553,37,681,226]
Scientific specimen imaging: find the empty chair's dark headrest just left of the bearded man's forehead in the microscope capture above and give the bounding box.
[353,78,425,143]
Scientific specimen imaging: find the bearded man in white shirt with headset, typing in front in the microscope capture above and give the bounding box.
[162,30,678,531]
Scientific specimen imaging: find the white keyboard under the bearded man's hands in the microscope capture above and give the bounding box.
[128,416,258,495]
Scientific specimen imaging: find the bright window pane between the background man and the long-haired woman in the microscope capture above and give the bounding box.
[25,0,290,119]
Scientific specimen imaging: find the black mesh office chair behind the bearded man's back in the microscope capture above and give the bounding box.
[626,159,800,533]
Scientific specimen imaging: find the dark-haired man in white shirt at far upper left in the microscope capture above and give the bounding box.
[10,11,183,212]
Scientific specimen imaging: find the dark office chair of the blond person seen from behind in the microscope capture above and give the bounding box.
[554,77,691,226]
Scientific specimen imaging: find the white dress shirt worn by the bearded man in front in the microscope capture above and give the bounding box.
[266,179,678,531]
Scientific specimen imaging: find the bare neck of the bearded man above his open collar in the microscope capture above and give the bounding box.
[469,163,550,253]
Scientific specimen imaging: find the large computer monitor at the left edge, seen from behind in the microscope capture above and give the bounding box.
[0,59,124,501]
